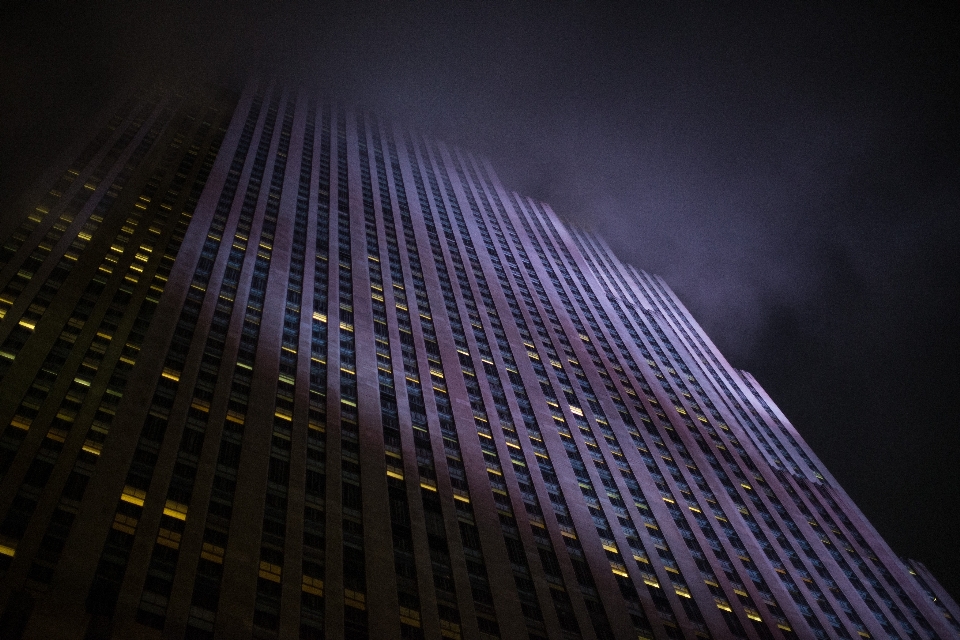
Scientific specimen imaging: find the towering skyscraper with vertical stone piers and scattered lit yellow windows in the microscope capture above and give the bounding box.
[0,82,960,640]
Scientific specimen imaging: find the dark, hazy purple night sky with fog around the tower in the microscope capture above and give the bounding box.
[0,2,960,597]
